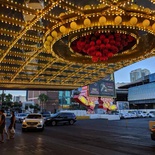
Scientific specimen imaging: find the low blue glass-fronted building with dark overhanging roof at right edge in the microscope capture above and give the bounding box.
[119,73,155,109]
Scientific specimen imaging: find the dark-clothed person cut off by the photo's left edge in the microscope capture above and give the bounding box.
[0,110,5,143]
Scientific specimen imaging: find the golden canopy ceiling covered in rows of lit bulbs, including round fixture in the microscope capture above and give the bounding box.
[0,0,155,89]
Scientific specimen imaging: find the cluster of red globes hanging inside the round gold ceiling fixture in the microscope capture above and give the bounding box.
[71,32,136,62]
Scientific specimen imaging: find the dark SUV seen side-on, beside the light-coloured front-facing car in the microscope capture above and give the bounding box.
[45,112,77,126]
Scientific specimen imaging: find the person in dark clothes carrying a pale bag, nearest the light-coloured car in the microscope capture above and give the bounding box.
[8,111,16,139]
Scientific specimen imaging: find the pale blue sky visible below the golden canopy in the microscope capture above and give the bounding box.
[0,57,155,96]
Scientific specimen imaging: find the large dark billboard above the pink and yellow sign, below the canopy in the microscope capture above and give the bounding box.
[88,74,115,97]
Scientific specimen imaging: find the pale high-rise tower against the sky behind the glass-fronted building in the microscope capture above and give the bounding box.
[130,68,150,82]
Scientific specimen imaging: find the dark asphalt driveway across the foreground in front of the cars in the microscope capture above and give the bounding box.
[0,118,155,155]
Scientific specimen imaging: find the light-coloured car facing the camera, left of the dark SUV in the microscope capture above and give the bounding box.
[22,113,44,131]
